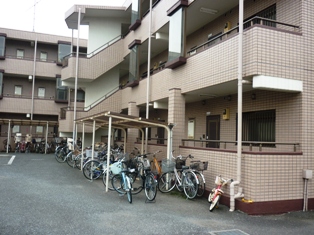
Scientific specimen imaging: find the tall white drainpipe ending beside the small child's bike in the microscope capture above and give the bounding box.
[229,0,244,211]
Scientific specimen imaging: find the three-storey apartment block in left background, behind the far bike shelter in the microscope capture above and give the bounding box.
[0,28,87,146]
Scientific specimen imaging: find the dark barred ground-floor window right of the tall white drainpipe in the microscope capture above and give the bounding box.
[238,110,276,142]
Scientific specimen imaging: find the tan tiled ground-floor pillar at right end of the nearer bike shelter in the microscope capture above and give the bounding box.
[168,88,186,156]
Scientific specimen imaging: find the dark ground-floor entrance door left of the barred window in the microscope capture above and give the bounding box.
[206,115,220,148]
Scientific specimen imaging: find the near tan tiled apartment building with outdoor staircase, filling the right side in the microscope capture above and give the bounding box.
[0,0,314,214]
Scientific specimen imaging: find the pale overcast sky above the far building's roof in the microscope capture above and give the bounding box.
[0,0,126,38]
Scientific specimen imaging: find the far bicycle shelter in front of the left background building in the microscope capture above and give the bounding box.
[0,118,59,154]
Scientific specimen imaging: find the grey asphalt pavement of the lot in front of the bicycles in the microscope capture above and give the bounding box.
[0,153,314,235]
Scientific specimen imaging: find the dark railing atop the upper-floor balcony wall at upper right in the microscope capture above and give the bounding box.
[187,16,300,56]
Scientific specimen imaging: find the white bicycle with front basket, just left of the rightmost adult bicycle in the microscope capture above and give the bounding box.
[158,155,199,199]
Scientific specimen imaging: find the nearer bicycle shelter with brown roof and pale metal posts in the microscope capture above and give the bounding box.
[75,111,174,192]
